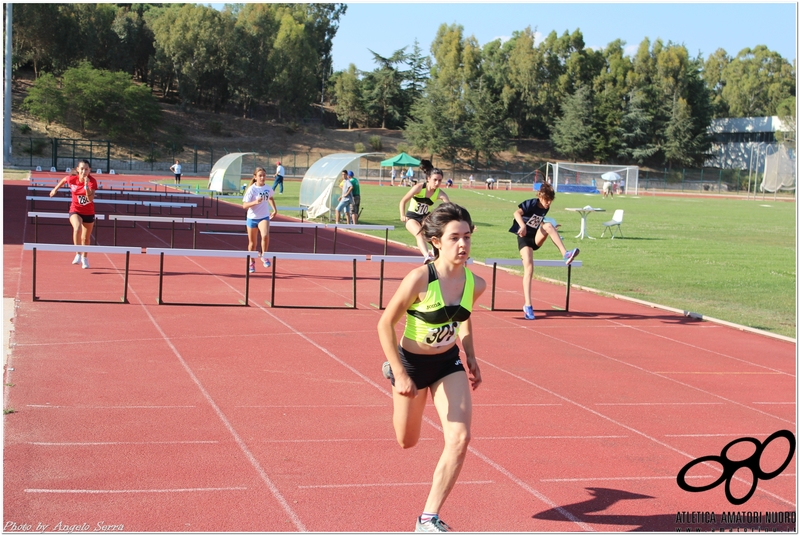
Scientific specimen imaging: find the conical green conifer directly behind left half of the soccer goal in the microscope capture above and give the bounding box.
[552,85,595,161]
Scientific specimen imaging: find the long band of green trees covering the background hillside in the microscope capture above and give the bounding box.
[13,3,796,168]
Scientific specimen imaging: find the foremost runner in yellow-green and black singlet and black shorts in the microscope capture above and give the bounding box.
[377,203,486,532]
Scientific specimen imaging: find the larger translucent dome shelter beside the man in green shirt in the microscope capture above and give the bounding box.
[300,152,382,219]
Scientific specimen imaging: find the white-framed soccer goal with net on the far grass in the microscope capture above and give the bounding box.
[547,162,638,195]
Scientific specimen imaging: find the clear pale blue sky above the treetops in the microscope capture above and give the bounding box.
[333,2,797,71]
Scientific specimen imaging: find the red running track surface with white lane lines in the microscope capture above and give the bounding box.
[3,177,796,532]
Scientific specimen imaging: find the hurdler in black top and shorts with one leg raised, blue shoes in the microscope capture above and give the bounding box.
[508,184,580,320]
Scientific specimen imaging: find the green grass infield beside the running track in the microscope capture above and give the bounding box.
[162,180,796,338]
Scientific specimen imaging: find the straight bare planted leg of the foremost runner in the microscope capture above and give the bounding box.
[424,371,472,513]
